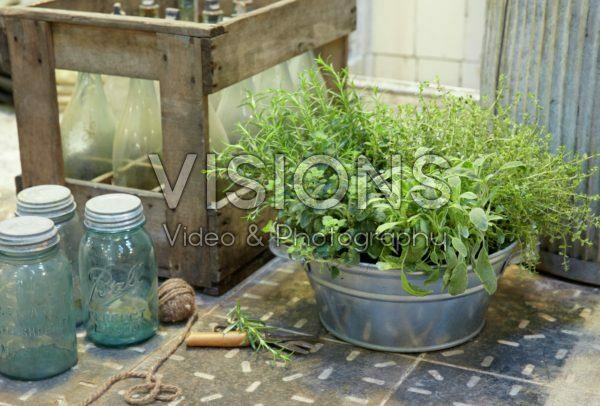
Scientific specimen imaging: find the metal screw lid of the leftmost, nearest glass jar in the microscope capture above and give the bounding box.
[0,216,60,254]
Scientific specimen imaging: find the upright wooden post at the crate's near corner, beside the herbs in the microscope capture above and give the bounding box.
[157,34,211,286]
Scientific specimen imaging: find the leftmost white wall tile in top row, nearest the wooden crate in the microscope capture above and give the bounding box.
[370,0,416,55]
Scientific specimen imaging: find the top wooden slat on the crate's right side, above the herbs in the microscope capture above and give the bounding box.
[211,0,356,92]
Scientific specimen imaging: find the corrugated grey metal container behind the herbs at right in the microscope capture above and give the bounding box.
[481,0,600,269]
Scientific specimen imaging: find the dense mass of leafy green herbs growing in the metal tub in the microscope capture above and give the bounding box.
[215,60,600,296]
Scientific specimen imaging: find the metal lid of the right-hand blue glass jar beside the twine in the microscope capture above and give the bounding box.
[83,193,146,233]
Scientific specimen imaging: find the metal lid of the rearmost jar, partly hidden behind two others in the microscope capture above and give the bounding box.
[16,185,77,220]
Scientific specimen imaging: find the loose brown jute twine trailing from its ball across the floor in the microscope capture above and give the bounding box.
[80,279,198,406]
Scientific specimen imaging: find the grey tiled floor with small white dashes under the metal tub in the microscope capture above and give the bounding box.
[0,259,600,406]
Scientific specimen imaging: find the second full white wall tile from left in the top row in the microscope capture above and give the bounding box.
[415,0,466,59]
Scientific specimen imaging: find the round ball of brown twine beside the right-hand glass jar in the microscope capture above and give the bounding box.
[158,278,196,323]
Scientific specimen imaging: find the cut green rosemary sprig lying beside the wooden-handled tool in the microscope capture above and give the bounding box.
[224,302,292,363]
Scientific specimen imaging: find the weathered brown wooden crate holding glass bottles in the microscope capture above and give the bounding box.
[0,0,356,294]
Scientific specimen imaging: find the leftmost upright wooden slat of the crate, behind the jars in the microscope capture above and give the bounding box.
[5,18,64,187]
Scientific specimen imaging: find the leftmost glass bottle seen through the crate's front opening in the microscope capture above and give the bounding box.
[60,72,115,180]
